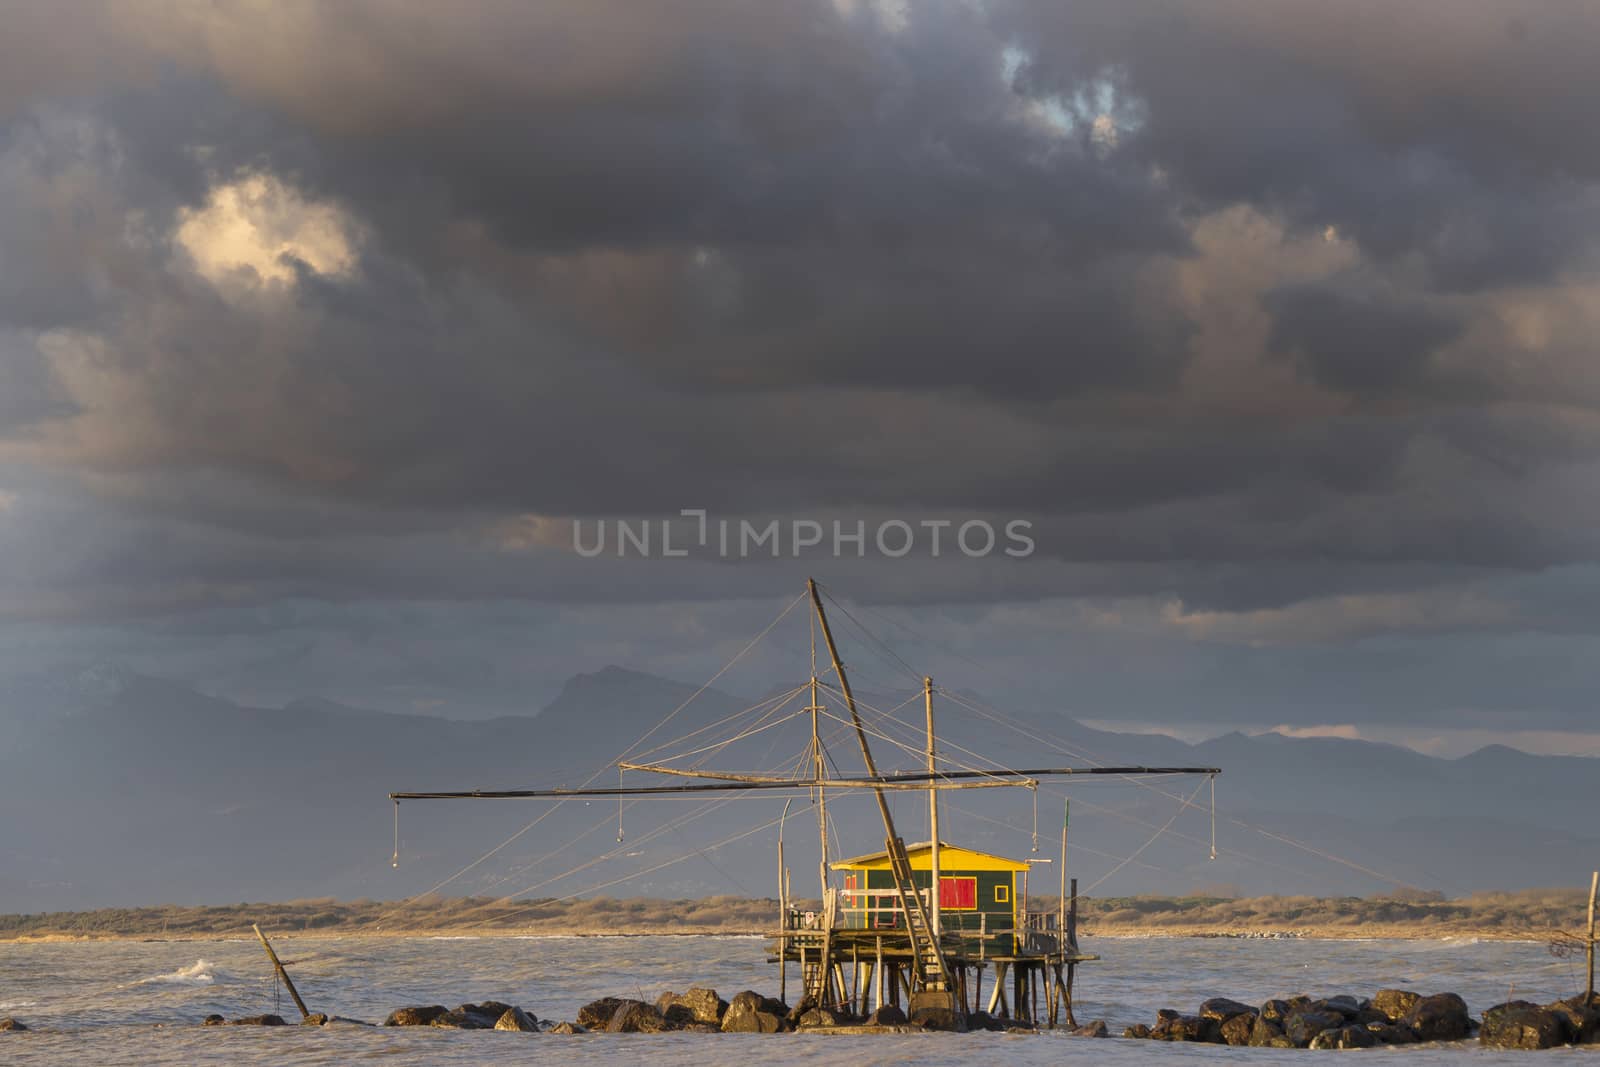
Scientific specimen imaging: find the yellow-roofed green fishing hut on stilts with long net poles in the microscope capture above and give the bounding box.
[389,579,1221,1029]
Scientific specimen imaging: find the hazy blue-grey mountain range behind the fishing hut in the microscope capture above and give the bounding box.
[0,667,1600,912]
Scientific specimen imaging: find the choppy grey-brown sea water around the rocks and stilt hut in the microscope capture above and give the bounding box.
[0,936,1600,1067]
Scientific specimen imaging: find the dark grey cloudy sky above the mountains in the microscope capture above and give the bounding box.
[0,0,1600,753]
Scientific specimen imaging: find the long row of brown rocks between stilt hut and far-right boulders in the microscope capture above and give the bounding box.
[1123,989,1477,1048]
